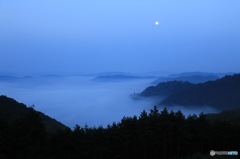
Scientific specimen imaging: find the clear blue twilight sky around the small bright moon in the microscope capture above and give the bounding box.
[0,0,240,74]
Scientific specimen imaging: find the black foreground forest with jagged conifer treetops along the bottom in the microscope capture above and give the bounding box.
[0,96,240,159]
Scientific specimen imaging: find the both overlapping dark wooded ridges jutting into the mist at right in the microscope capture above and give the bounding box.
[140,74,240,110]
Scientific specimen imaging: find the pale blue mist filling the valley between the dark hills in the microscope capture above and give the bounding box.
[0,77,218,127]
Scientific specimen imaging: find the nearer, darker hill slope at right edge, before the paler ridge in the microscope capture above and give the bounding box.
[161,74,240,109]
